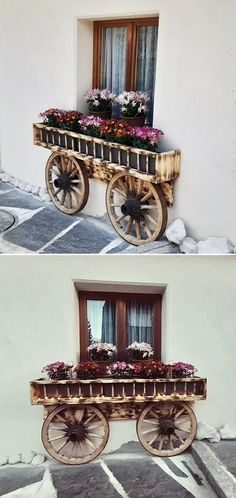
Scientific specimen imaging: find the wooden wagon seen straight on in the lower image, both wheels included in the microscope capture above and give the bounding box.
[30,377,206,465]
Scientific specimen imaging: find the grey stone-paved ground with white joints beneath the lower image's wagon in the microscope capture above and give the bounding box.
[0,443,217,498]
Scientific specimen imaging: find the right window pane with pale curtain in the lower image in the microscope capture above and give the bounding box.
[126,301,154,346]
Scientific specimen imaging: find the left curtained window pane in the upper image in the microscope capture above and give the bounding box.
[101,27,127,94]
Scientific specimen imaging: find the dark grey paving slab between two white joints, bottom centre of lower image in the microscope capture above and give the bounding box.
[106,458,194,498]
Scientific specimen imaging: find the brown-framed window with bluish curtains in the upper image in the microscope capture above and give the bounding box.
[93,18,158,120]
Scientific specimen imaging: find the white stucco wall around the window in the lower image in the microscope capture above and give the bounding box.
[0,256,236,455]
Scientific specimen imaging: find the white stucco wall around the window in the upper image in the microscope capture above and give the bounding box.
[0,0,236,240]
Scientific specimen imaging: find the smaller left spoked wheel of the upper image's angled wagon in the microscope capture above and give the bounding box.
[45,152,89,214]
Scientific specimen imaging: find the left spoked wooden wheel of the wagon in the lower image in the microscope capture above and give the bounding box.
[42,405,109,465]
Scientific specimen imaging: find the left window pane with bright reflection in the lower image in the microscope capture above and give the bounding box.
[87,299,116,344]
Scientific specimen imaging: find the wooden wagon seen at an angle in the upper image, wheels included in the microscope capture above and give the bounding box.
[33,123,180,245]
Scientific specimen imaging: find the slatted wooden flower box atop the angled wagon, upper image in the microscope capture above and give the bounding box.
[33,123,180,183]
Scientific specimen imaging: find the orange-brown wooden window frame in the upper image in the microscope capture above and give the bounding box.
[93,17,159,91]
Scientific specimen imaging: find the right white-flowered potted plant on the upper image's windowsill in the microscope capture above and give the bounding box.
[116,91,150,126]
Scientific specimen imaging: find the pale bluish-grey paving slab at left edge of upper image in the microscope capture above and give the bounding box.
[0,188,45,209]
